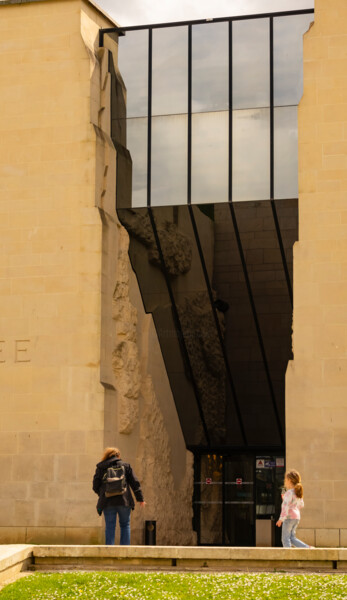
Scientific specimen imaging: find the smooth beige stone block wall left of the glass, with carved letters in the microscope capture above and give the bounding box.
[0,1,115,543]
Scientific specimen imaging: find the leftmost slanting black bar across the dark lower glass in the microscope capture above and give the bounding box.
[148,207,211,448]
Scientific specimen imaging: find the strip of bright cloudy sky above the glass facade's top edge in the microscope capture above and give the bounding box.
[97,0,314,27]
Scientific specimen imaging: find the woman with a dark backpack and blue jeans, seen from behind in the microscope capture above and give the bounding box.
[93,448,146,546]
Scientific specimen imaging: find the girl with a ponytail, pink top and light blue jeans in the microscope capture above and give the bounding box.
[276,469,311,548]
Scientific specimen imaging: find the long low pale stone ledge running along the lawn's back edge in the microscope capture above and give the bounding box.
[31,545,347,571]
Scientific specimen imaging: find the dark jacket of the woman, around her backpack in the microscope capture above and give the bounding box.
[93,456,144,515]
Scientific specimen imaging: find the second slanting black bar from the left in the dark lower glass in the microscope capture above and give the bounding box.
[189,206,248,446]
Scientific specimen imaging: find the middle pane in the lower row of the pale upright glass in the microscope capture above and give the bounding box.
[191,111,229,204]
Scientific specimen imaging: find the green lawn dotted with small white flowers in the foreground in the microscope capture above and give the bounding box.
[0,572,347,600]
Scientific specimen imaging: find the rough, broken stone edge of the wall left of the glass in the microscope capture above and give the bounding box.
[92,39,196,545]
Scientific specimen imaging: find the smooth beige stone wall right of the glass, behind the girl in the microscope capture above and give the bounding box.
[286,0,347,546]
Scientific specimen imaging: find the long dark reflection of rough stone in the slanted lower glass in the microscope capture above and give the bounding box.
[163,206,226,445]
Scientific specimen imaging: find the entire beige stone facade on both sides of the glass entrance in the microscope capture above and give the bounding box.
[0,0,347,546]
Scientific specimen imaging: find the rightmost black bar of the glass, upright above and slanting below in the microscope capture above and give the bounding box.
[269,17,293,308]
